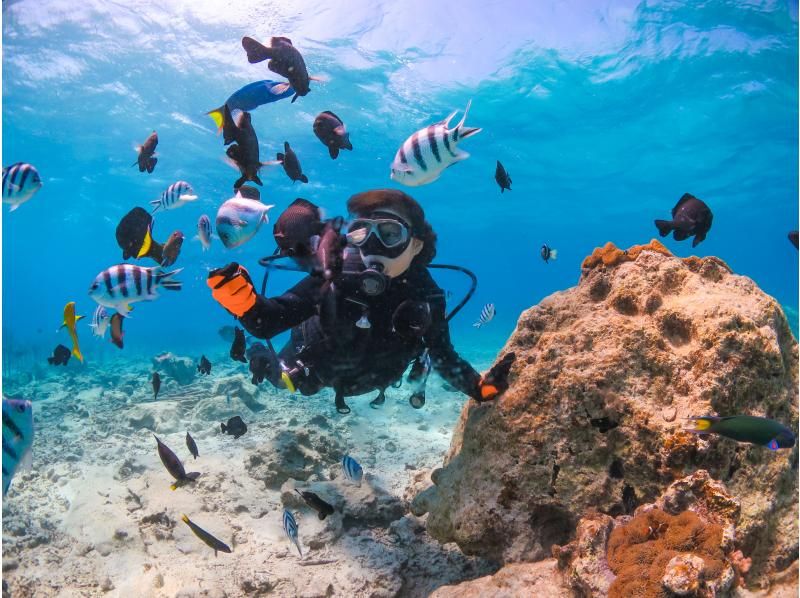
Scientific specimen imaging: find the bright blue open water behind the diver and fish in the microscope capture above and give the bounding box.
[2,0,798,367]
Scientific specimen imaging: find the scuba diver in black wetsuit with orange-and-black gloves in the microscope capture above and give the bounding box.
[207,189,514,413]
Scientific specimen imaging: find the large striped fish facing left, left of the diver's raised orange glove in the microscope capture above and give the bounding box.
[89,264,183,316]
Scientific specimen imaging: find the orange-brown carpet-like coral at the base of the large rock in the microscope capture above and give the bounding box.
[607,509,726,598]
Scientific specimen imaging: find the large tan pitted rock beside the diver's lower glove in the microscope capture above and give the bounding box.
[412,240,798,584]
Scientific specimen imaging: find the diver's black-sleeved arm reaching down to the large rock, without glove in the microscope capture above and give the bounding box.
[425,300,481,400]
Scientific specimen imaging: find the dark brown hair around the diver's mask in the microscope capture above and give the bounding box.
[347,189,436,266]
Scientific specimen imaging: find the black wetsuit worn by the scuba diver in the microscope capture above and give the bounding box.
[234,266,480,397]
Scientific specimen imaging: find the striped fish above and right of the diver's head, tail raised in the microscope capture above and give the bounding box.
[391,100,481,187]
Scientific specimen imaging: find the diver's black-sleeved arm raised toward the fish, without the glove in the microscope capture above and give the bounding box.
[239,276,322,338]
